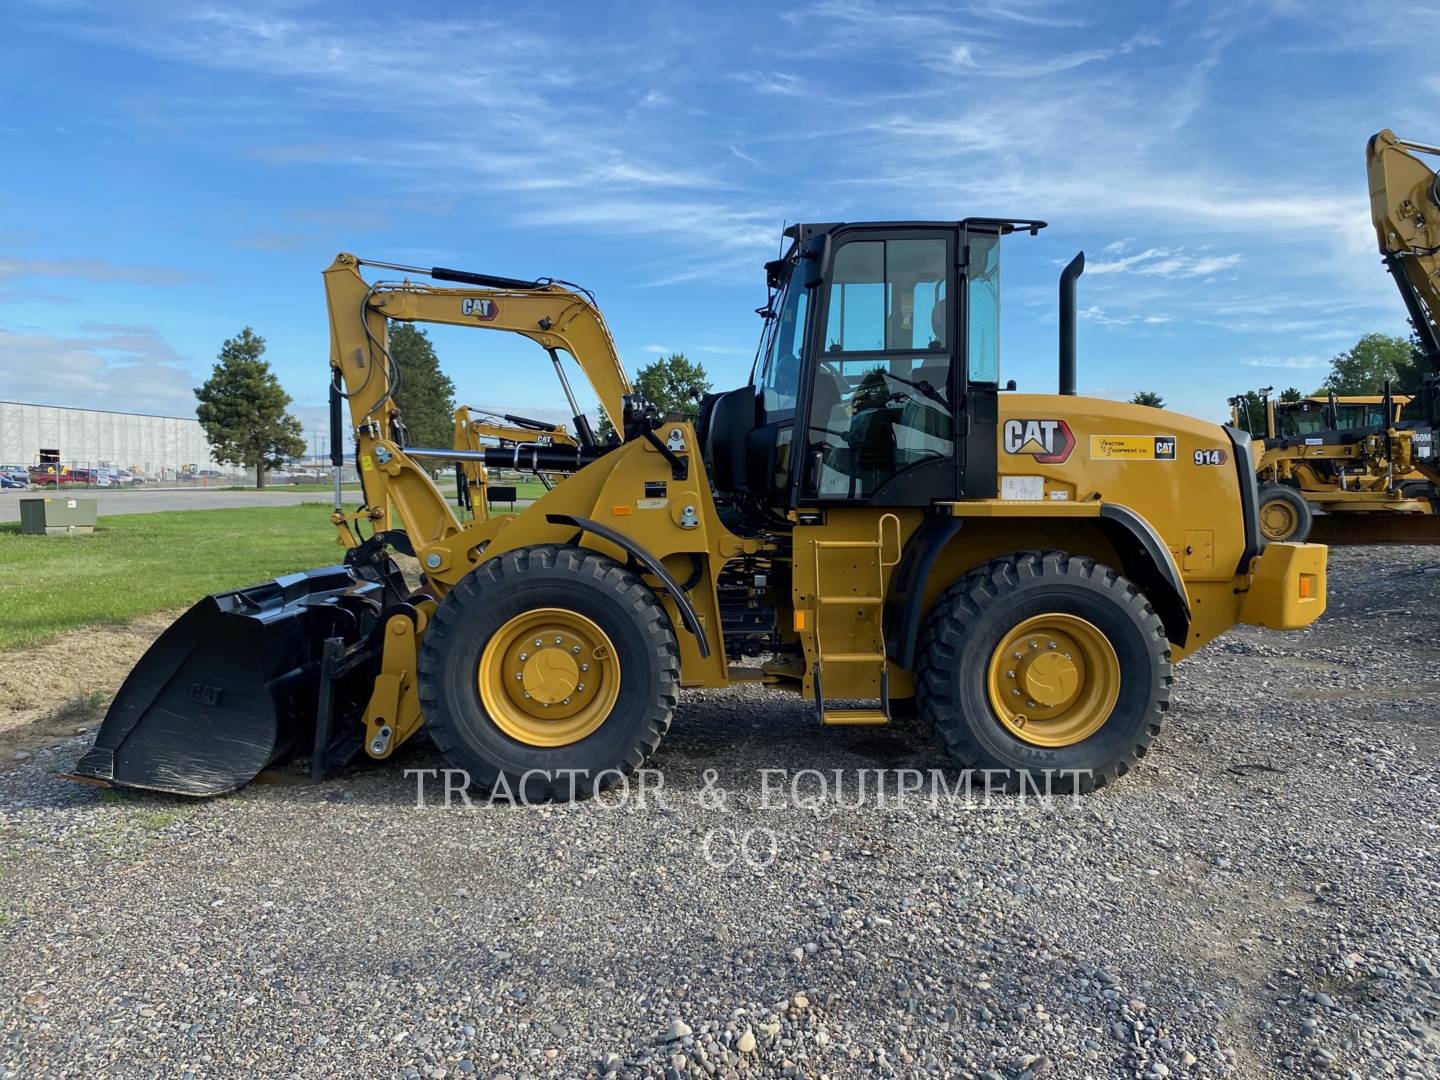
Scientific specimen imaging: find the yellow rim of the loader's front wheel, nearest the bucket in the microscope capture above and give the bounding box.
[478,608,621,747]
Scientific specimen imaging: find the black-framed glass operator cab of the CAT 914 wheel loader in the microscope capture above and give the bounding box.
[701,219,1044,507]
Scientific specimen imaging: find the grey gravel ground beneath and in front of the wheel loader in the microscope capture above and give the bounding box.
[0,549,1440,1080]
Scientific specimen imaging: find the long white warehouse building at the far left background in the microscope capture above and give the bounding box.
[0,402,217,478]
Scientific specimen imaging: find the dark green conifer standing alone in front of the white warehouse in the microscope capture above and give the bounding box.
[194,327,305,488]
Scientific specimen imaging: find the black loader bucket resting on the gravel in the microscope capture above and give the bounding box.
[73,564,403,795]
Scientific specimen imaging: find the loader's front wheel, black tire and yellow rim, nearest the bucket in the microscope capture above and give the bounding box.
[419,546,680,801]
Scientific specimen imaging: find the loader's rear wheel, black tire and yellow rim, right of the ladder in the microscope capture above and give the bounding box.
[916,552,1172,791]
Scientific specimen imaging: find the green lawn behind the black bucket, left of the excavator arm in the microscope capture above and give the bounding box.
[0,503,343,650]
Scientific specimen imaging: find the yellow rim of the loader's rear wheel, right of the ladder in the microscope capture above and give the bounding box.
[988,612,1120,747]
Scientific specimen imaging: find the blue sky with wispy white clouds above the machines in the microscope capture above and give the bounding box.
[0,0,1440,443]
